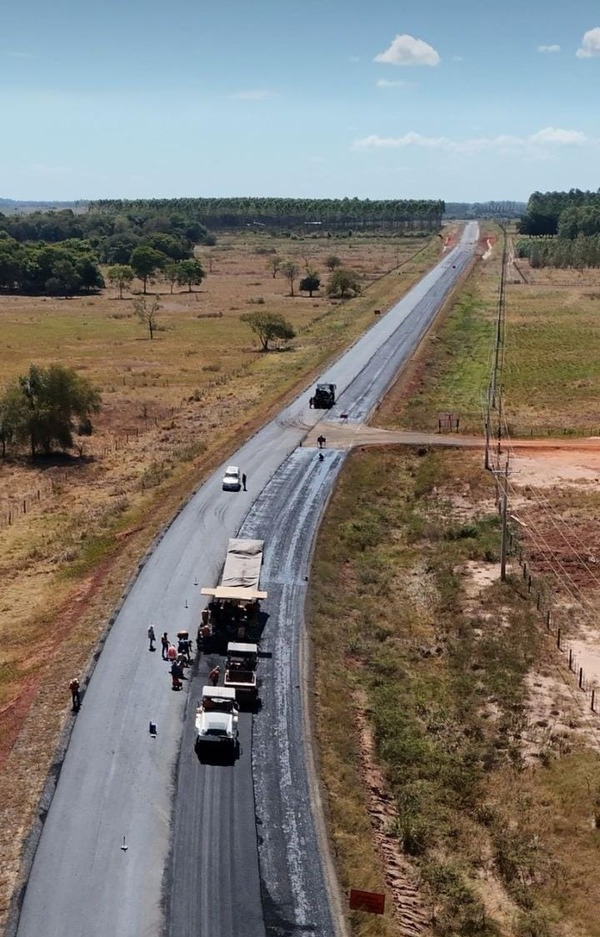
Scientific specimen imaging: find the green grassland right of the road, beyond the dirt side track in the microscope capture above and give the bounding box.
[377,231,600,437]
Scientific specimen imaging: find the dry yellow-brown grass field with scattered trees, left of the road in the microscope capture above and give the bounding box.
[0,227,440,925]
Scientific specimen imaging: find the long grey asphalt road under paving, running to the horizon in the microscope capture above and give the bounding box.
[17,223,478,937]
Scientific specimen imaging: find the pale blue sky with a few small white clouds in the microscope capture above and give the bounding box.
[0,0,600,202]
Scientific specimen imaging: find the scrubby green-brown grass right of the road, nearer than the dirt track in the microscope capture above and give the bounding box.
[310,450,600,937]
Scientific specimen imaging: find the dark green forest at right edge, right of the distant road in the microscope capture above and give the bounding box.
[516,189,600,270]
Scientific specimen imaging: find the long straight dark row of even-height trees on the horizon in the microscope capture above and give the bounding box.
[89,198,445,233]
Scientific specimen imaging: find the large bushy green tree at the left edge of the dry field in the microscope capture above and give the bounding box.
[0,364,101,458]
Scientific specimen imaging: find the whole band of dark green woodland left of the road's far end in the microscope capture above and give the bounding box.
[0,198,444,296]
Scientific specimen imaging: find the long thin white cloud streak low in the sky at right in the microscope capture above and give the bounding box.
[352,127,591,153]
